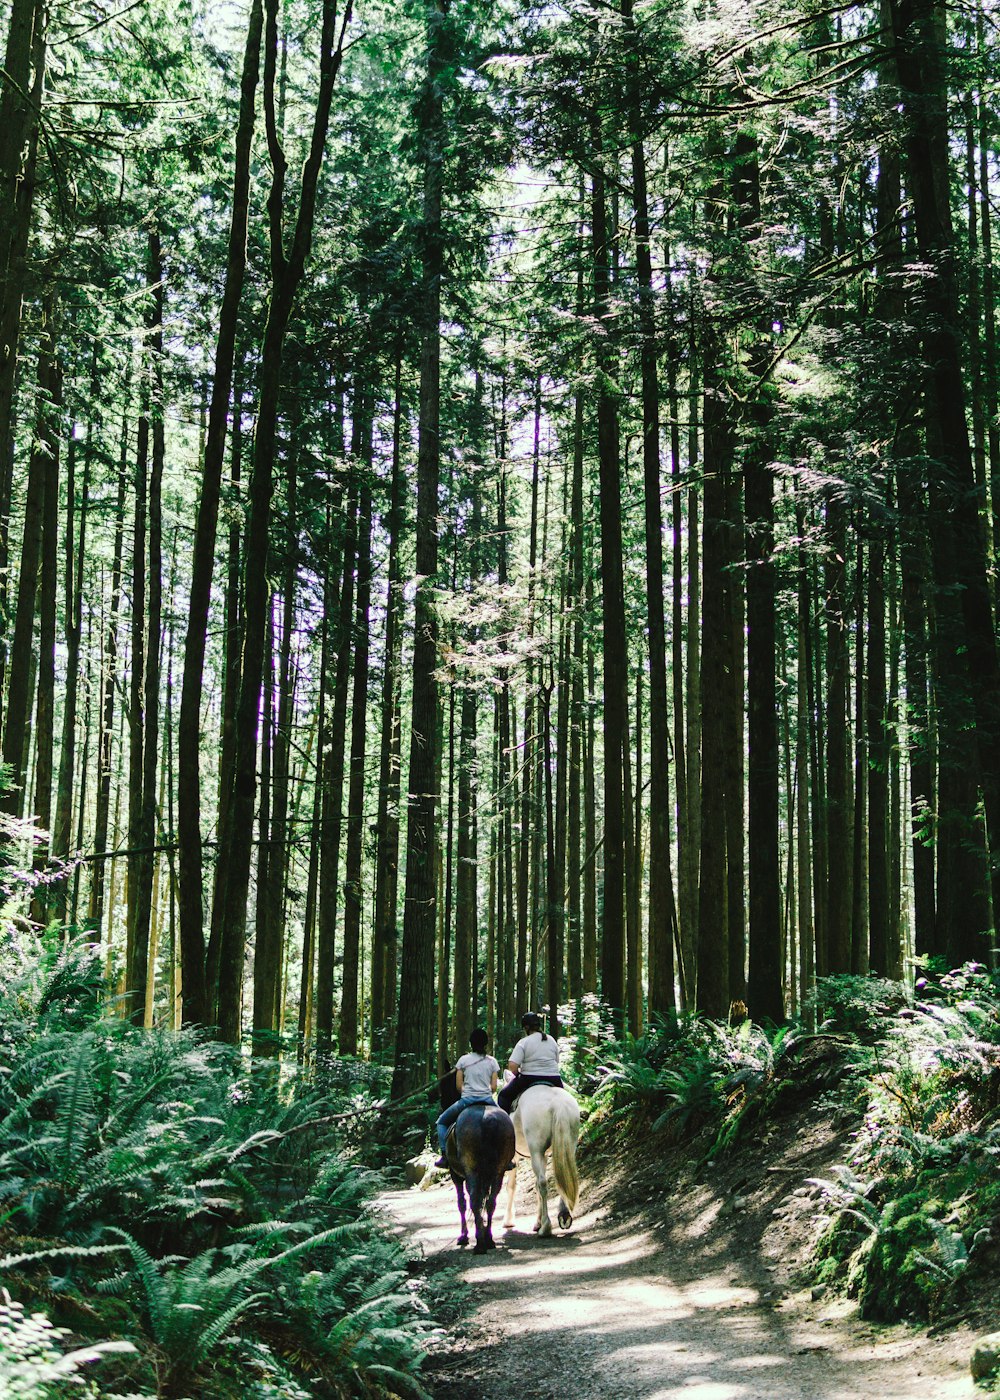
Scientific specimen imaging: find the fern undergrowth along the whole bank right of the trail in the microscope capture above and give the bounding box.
[587,965,1000,1322]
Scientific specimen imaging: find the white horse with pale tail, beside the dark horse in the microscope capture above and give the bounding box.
[504,1084,580,1235]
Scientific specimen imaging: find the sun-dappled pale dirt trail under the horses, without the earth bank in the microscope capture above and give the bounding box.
[382,1166,976,1400]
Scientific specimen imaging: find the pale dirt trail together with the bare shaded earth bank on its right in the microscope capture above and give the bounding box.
[381,1107,992,1400]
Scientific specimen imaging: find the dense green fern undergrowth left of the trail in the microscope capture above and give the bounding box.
[0,932,431,1400]
